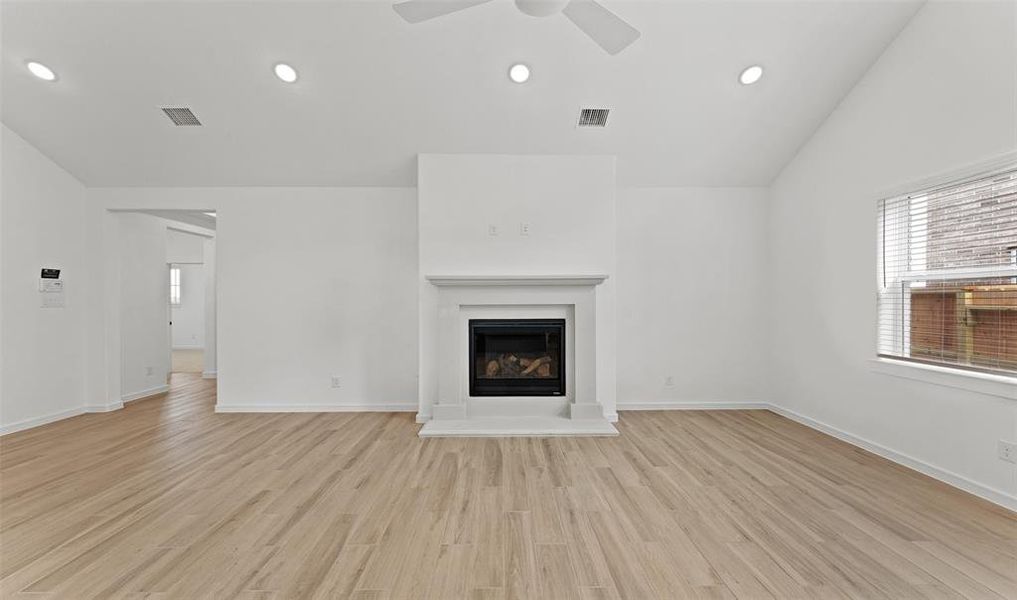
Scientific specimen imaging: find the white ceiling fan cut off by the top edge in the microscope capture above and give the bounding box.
[393,0,640,55]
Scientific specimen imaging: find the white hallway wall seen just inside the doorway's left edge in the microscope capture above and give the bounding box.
[114,213,170,401]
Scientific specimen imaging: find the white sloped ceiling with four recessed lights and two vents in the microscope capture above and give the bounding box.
[2,0,920,186]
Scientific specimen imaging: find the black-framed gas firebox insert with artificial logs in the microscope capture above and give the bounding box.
[470,318,565,397]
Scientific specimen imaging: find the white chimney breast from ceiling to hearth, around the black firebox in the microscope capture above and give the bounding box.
[418,155,616,435]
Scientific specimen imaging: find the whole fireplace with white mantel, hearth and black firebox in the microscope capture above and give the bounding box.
[417,274,618,437]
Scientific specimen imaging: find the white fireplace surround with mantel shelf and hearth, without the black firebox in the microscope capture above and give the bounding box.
[418,275,617,437]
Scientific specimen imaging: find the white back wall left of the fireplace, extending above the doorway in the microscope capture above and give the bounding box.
[88,187,417,411]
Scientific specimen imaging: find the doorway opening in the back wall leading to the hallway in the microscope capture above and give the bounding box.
[110,209,218,404]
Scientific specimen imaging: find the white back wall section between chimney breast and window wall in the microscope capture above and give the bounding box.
[617,188,769,410]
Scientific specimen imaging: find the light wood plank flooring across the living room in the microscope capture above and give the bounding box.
[0,373,1017,600]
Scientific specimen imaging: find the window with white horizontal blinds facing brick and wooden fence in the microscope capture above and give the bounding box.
[878,168,1017,375]
